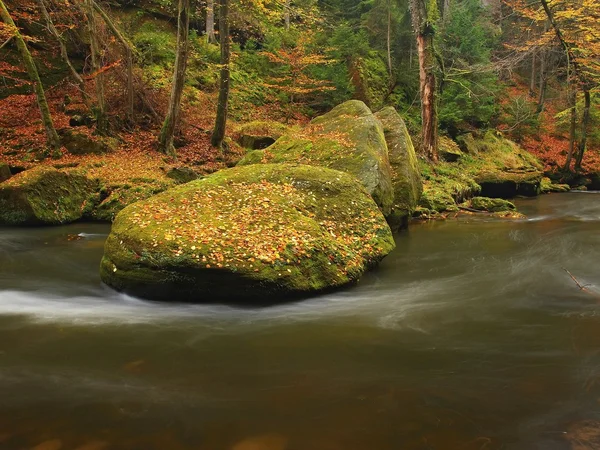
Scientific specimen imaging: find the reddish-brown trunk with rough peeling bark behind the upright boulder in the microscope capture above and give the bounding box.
[410,0,438,161]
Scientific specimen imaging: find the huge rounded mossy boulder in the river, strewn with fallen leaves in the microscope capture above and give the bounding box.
[100,164,394,302]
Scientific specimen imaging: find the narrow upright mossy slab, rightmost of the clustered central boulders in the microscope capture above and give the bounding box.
[375,106,423,231]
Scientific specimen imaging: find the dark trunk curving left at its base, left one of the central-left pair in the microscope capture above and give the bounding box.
[158,0,190,155]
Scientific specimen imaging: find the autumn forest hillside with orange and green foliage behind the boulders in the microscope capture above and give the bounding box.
[0,0,600,177]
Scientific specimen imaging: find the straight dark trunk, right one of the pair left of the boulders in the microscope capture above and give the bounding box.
[210,0,231,148]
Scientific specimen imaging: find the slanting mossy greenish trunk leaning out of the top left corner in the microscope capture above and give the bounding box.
[0,0,61,153]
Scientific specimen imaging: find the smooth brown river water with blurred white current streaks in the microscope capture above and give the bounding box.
[0,193,600,450]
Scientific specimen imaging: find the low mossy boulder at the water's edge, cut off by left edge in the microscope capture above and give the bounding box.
[0,166,98,225]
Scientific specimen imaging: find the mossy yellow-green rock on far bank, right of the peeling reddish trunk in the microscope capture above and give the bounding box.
[459,131,543,198]
